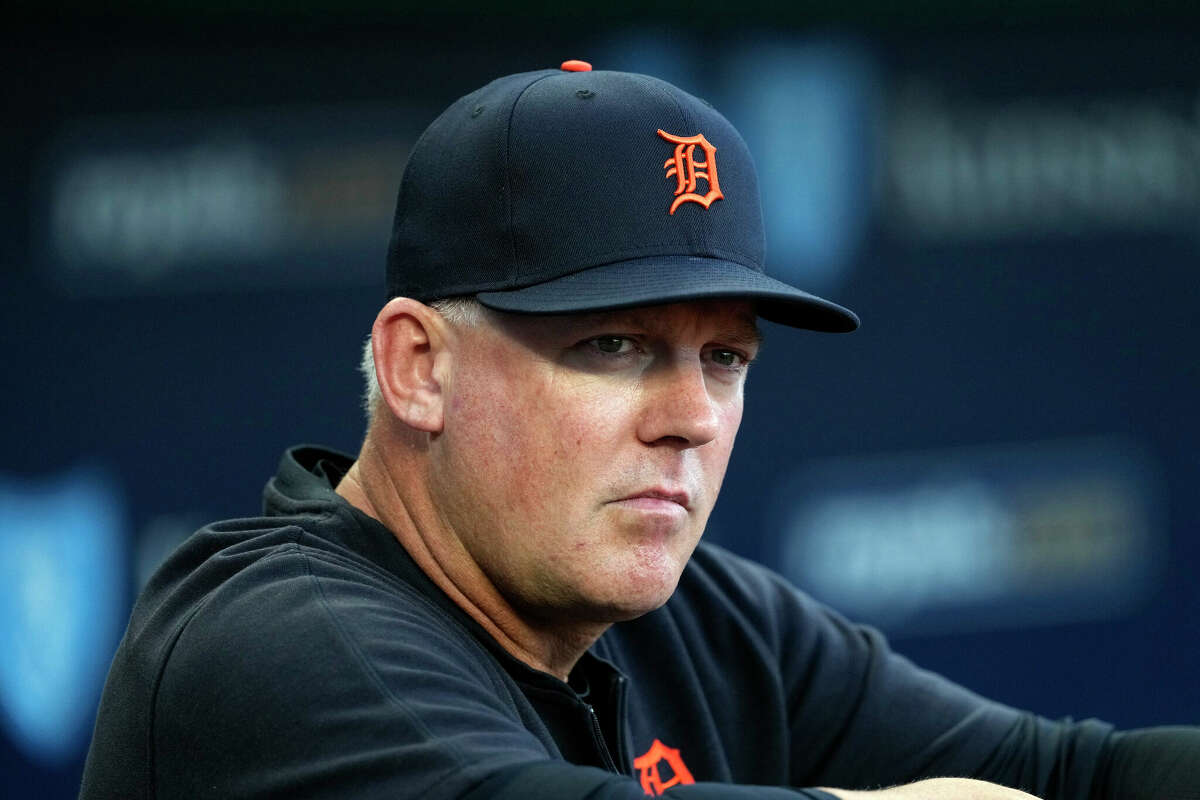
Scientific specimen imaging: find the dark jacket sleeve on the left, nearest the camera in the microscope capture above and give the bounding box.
[150,546,828,800]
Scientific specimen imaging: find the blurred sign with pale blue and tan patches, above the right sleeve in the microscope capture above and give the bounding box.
[778,440,1165,633]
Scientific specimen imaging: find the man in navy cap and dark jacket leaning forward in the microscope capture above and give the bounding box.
[83,61,1200,800]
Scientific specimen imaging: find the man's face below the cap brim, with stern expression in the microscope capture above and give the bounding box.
[431,301,760,622]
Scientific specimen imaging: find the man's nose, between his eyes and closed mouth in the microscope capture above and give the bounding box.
[637,359,720,447]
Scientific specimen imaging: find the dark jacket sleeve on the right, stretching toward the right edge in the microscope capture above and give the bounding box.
[748,561,1112,800]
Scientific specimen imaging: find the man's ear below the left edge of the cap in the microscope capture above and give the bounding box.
[371,297,450,433]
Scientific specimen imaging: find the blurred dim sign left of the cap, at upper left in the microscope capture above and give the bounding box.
[37,108,426,294]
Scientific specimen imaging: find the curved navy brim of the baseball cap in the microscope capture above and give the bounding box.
[476,255,858,333]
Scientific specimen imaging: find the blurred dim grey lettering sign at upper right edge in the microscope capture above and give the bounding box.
[882,86,1200,241]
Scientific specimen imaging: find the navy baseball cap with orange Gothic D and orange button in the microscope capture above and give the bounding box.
[388,61,858,332]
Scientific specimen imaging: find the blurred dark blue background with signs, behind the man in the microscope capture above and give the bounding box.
[0,1,1200,800]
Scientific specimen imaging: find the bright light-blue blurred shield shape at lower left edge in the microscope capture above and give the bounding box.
[0,470,128,764]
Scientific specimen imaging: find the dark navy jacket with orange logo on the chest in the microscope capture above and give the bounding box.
[83,447,1114,800]
